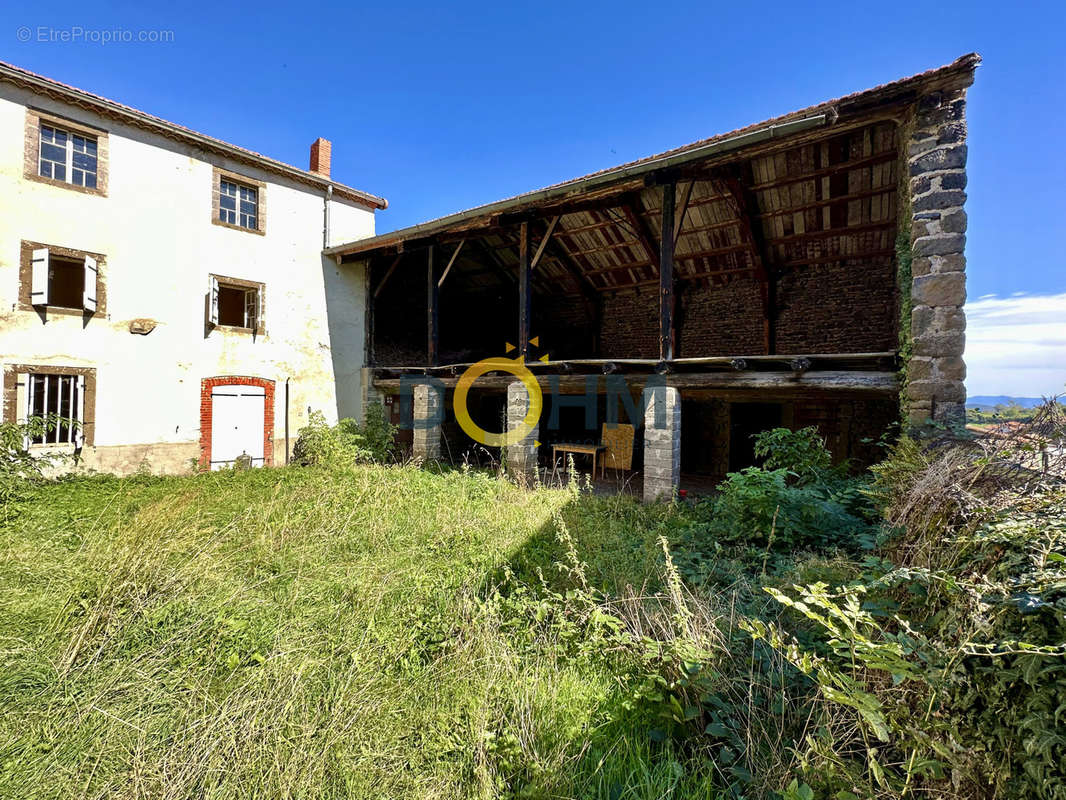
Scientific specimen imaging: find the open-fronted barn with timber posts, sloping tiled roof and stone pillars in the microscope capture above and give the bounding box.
[325,54,980,498]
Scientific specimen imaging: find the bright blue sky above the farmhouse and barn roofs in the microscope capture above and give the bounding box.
[0,0,1066,395]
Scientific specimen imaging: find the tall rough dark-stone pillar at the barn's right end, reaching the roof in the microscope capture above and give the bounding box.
[905,78,972,427]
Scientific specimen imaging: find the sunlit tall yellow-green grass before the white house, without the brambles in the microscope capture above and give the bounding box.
[0,466,715,799]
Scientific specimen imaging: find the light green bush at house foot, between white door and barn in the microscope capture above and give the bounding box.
[292,404,395,466]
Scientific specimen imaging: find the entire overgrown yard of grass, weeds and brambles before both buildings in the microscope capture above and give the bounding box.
[0,430,1066,800]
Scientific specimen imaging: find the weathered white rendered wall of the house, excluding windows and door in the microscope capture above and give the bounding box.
[0,72,374,473]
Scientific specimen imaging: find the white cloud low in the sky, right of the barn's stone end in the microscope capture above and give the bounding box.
[966,292,1066,397]
